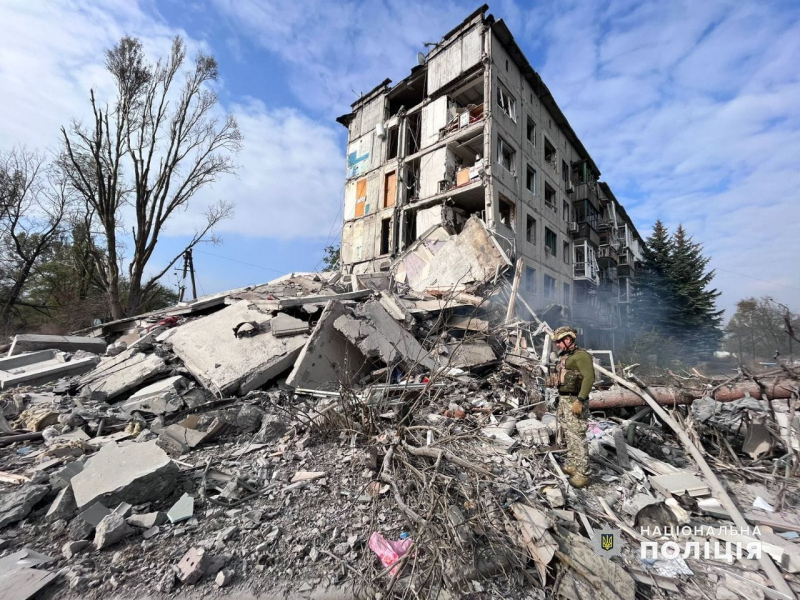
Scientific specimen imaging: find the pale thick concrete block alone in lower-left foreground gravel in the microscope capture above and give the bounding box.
[72,441,178,508]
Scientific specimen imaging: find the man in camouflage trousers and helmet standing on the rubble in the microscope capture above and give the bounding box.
[553,327,594,488]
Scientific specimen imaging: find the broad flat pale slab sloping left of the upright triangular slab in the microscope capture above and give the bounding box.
[169,300,308,395]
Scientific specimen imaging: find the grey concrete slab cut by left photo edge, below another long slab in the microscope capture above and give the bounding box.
[0,350,100,390]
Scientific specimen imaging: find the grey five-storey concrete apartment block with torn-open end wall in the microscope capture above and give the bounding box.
[338,5,641,342]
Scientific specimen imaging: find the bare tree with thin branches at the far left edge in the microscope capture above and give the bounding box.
[0,148,69,326]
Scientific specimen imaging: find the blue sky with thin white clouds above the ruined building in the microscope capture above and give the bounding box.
[0,0,800,316]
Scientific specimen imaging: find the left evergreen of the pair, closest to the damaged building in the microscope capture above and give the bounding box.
[631,219,675,335]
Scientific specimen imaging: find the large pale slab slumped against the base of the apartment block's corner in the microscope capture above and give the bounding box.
[392,217,511,292]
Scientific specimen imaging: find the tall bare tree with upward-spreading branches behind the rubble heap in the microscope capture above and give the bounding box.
[60,37,242,319]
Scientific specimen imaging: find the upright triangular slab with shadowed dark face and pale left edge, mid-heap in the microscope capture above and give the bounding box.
[286,300,370,391]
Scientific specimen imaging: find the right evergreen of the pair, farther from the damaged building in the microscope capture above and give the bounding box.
[668,225,723,359]
